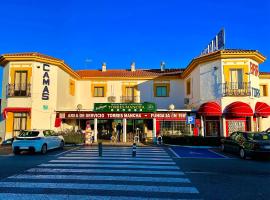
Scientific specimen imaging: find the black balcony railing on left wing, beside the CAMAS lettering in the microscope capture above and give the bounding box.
[7,83,31,97]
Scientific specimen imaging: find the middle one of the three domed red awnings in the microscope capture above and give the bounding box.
[224,101,253,117]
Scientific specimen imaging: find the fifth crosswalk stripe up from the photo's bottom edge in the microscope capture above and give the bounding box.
[39,163,179,169]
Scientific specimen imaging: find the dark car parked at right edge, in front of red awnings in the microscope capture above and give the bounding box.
[221,132,270,159]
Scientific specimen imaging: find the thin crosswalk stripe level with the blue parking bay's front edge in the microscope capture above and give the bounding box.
[58,156,172,162]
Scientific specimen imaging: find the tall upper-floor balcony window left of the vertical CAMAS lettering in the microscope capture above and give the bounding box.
[14,71,27,96]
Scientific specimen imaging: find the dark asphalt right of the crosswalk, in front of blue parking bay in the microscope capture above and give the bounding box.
[168,149,270,200]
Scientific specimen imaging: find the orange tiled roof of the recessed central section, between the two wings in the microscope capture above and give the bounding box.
[76,69,183,78]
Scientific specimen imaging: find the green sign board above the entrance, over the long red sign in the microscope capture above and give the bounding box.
[94,102,156,112]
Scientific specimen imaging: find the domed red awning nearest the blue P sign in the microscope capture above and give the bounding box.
[198,102,222,116]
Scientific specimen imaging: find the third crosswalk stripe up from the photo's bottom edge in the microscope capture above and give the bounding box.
[9,174,190,183]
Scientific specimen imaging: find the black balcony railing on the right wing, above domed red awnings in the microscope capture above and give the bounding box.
[222,82,251,96]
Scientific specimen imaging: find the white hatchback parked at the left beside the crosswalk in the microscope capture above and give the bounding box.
[12,130,65,154]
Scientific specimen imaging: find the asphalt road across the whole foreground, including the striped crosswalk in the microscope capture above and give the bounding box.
[0,147,270,200]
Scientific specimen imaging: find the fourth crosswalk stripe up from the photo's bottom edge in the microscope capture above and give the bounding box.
[27,168,184,175]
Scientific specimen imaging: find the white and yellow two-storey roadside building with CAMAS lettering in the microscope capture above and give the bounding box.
[0,49,270,142]
